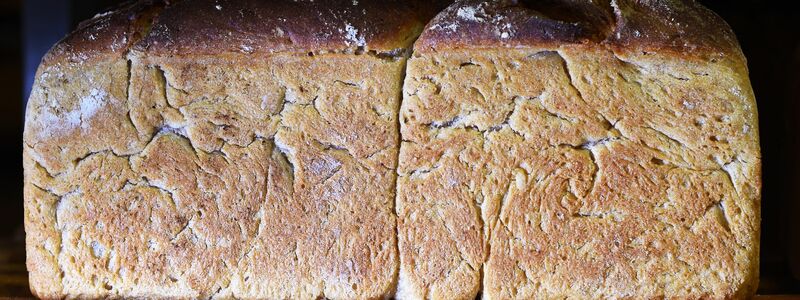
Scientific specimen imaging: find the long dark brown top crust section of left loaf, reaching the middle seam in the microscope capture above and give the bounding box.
[136,0,435,55]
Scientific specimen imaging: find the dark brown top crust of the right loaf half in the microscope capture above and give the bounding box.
[415,0,740,54]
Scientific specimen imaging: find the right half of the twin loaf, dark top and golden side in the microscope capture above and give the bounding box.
[397,0,761,299]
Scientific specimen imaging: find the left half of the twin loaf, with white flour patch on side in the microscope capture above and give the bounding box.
[24,0,433,299]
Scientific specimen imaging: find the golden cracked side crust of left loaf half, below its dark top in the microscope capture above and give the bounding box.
[24,54,404,299]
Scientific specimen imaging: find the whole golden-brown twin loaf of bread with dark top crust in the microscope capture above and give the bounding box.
[23,0,760,299]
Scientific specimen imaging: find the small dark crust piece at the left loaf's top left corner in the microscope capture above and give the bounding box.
[43,0,164,63]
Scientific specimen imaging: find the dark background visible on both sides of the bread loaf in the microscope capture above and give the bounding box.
[0,0,800,296]
